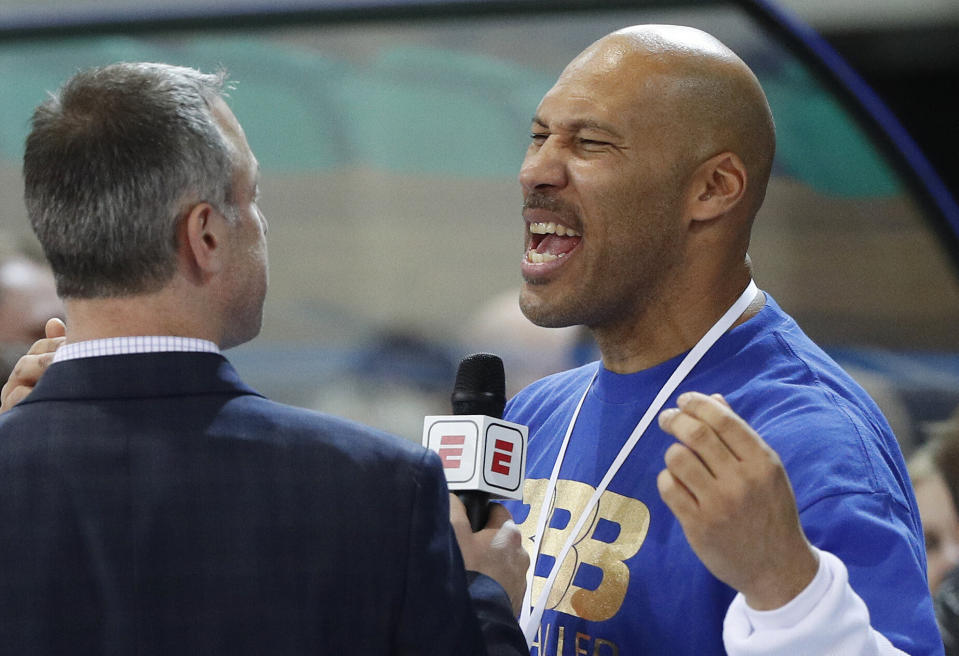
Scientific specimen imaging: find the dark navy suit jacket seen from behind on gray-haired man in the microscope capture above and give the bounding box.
[0,353,527,656]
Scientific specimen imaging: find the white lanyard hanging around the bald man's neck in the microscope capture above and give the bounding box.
[520,280,759,646]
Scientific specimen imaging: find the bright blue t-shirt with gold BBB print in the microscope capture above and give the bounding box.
[505,295,942,656]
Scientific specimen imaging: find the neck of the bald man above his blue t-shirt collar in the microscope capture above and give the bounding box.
[591,270,766,374]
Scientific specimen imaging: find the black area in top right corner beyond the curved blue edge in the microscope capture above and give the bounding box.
[820,24,959,197]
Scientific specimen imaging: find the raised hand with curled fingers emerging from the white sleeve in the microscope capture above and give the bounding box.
[657,392,818,610]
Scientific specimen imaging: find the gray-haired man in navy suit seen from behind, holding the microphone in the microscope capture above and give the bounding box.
[0,64,529,656]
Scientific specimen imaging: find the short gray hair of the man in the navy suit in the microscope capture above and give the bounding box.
[23,63,233,298]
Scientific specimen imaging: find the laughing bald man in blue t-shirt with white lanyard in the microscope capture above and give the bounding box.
[506,25,942,656]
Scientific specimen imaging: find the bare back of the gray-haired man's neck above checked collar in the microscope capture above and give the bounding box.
[64,290,220,344]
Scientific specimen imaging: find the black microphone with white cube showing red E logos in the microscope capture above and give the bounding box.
[423,353,529,533]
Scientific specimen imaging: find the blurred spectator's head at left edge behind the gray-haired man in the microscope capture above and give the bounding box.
[0,235,63,381]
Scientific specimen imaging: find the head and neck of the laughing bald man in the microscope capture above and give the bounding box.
[519,25,774,358]
